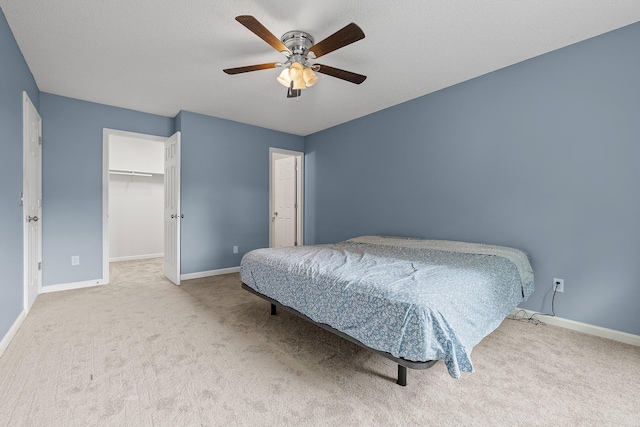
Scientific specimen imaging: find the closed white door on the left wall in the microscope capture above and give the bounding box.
[22,92,42,312]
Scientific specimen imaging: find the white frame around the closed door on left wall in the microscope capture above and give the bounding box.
[21,91,42,313]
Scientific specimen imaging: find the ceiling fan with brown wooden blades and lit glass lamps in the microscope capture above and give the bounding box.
[223,15,367,98]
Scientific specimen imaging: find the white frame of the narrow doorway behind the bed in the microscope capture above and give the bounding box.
[269,147,304,247]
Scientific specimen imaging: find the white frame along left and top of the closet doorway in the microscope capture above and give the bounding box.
[102,128,168,285]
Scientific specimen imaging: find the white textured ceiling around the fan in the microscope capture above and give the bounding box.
[0,0,640,135]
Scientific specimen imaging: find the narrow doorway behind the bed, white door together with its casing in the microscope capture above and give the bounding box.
[269,147,304,247]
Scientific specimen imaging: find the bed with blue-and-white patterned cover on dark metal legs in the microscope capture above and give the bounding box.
[240,236,533,385]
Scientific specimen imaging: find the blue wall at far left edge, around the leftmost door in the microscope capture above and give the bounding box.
[0,9,39,339]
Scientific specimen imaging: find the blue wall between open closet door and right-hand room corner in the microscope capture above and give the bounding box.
[176,111,304,274]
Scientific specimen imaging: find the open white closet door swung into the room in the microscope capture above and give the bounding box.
[164,132,182,285]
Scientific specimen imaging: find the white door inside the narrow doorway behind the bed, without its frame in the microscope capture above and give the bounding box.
[272,156,297,248]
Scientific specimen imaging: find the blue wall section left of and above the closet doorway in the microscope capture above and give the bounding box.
[40,92,173,286]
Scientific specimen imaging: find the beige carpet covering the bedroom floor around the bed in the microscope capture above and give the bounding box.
[0,260,640,426]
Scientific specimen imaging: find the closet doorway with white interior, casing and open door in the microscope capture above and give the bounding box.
[103,129,180,284]
